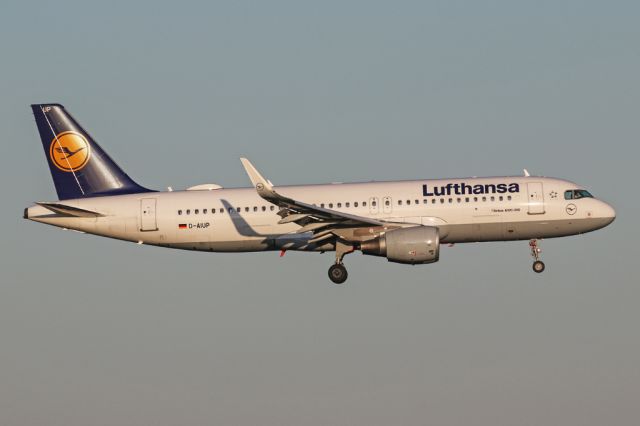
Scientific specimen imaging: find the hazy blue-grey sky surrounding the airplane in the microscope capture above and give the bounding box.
[0,1,640,426]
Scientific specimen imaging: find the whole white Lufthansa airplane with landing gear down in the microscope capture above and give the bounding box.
[24,103,616,284]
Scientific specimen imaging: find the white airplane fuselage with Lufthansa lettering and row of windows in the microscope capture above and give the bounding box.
[25,176,615,252]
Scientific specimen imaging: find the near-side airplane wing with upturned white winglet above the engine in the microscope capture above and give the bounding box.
[240,158,390,243]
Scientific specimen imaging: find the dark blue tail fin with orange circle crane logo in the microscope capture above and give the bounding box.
[31,104,150,200]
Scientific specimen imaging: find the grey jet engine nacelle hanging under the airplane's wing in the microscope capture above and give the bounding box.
[360,226,440,265]
